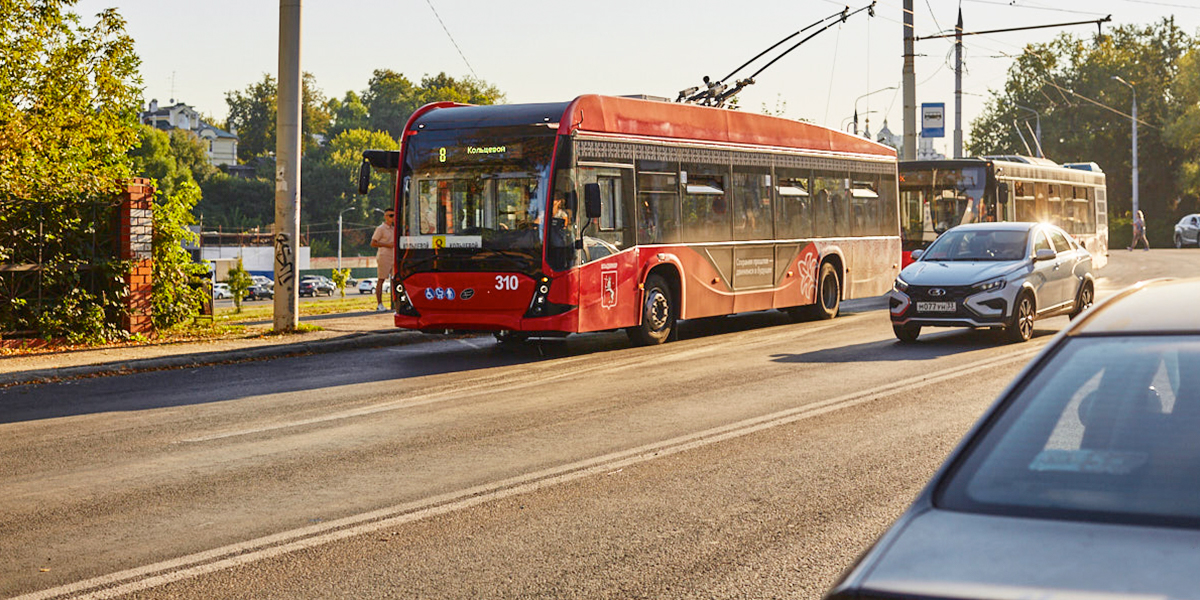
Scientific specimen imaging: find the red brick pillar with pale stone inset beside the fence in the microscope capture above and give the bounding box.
[118,178,154,334]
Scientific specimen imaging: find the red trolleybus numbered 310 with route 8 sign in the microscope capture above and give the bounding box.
[360,96,900,344]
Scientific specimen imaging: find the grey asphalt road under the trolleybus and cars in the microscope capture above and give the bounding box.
[0,250,1200,598]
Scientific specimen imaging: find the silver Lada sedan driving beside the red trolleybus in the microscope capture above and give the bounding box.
[888,223,1096,342]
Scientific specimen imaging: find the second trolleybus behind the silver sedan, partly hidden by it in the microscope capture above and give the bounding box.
[900,156,1109,269]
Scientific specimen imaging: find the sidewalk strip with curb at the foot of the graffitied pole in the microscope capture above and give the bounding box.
[0,311,424,388]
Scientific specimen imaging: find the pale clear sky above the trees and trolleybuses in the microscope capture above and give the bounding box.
[74,0,1200,154]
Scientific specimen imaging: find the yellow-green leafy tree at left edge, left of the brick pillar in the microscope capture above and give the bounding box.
[0,0,142,341]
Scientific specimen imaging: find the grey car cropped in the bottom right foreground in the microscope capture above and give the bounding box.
[826,280,1200,600]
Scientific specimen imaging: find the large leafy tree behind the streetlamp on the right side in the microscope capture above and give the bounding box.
[967,18,1195,242]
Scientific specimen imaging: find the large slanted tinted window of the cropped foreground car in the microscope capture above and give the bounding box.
[937,336,1200,526]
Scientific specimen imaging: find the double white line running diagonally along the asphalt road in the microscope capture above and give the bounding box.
[23,344,1042,600]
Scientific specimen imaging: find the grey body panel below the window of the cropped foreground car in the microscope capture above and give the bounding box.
[863,510,1200,600]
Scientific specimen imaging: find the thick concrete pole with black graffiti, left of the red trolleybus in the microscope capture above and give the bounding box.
[275,0,301,331]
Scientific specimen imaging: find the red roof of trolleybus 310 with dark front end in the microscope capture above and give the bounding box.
[409,95,896,158]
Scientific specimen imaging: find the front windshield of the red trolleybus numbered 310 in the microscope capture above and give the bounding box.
[397,127,554,271]
